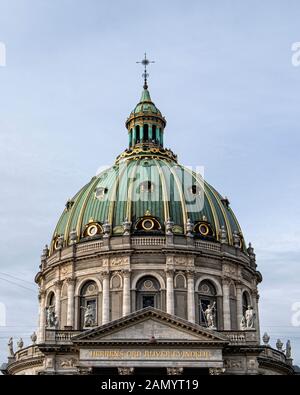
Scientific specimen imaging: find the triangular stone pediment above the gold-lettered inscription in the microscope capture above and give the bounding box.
[72,307,228,344]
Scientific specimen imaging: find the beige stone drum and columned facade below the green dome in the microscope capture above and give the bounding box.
[0,236,293,374]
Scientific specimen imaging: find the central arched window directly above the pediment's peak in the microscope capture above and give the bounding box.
[136,276,160,310]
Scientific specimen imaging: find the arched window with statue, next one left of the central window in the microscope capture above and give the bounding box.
[80,281,98,329]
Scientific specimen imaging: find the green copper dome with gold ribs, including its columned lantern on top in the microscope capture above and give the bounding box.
[50,85,245,252]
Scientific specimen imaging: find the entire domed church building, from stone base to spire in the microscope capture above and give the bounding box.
[2,75,293,375]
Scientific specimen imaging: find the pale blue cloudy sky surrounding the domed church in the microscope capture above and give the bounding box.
[0,0,300,364]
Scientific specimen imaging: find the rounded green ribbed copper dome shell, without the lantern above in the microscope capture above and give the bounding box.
[54,156,241,252]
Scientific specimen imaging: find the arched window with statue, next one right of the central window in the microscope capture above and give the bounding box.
[199,280,217,327]
